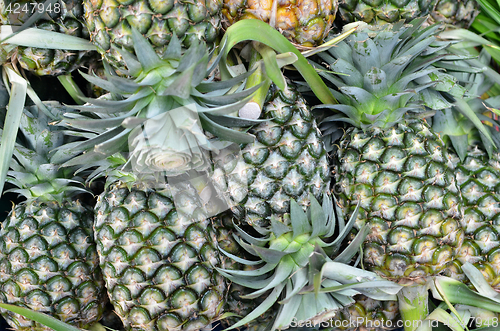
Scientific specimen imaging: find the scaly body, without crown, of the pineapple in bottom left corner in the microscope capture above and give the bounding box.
[0,200,106,331]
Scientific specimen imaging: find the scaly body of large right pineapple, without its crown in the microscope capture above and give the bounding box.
[335,121,464,280]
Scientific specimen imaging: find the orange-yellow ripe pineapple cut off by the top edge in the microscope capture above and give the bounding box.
[222,0,337,46]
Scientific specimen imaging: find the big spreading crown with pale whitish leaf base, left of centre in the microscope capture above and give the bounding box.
[58,29,260,183]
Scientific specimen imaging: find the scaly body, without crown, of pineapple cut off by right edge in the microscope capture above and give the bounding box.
[447,145,500,291]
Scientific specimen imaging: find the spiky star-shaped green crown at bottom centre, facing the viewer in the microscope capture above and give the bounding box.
[218,195,401,330]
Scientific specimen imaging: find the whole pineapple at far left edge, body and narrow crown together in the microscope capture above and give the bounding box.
[0,103,106,331]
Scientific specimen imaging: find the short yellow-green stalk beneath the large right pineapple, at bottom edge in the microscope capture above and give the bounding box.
[397,283,429,331]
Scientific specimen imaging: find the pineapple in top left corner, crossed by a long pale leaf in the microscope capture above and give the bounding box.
[0,0,96,76]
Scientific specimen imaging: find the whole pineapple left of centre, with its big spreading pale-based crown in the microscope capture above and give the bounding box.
[52,25,255,331]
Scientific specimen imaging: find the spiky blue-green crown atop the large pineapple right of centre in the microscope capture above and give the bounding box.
[314,18,463,130]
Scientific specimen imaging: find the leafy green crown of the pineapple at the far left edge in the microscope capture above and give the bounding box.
[6,102,87,202]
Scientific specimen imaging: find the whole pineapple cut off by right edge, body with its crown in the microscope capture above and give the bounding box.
[433,50,500,289]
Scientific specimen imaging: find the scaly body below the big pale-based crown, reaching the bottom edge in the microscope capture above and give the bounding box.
[94,182,226,331]
